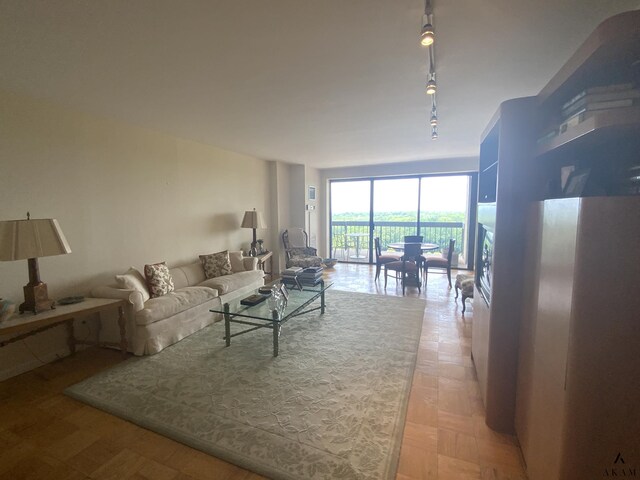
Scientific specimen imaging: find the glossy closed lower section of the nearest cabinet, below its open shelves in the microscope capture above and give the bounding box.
[516,196,640,480]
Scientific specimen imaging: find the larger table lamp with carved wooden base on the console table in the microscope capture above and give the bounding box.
[0,213,71,313]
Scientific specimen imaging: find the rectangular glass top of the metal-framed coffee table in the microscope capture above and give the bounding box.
[210,282,333,323]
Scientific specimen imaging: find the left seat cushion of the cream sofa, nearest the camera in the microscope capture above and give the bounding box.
[136,286,218,325]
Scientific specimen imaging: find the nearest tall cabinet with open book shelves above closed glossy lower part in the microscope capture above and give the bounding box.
[504,11,640,480]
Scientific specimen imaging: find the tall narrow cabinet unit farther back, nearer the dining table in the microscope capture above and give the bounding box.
[471,97,535,433]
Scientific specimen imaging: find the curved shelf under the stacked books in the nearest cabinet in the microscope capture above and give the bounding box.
[536,106,640,157]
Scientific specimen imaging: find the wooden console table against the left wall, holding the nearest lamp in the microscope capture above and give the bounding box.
[0,298,127,356]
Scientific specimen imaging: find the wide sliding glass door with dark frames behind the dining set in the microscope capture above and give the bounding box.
[330,174,476,268]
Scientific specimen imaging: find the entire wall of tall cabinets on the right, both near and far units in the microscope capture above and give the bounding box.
[472,11,640,480]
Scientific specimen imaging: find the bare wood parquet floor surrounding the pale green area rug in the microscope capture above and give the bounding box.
[0,264,526,480]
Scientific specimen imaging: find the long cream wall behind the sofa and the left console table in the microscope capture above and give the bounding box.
[0,90,277,378]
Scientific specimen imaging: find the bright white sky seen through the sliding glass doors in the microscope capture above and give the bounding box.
[331,175,469,213]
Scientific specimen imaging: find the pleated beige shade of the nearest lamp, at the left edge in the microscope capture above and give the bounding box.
[0,218,71,261]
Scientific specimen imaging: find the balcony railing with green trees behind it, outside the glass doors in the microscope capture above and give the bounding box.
[331,221,465,263]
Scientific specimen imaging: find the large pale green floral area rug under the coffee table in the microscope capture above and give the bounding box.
[66,289,425,480]
